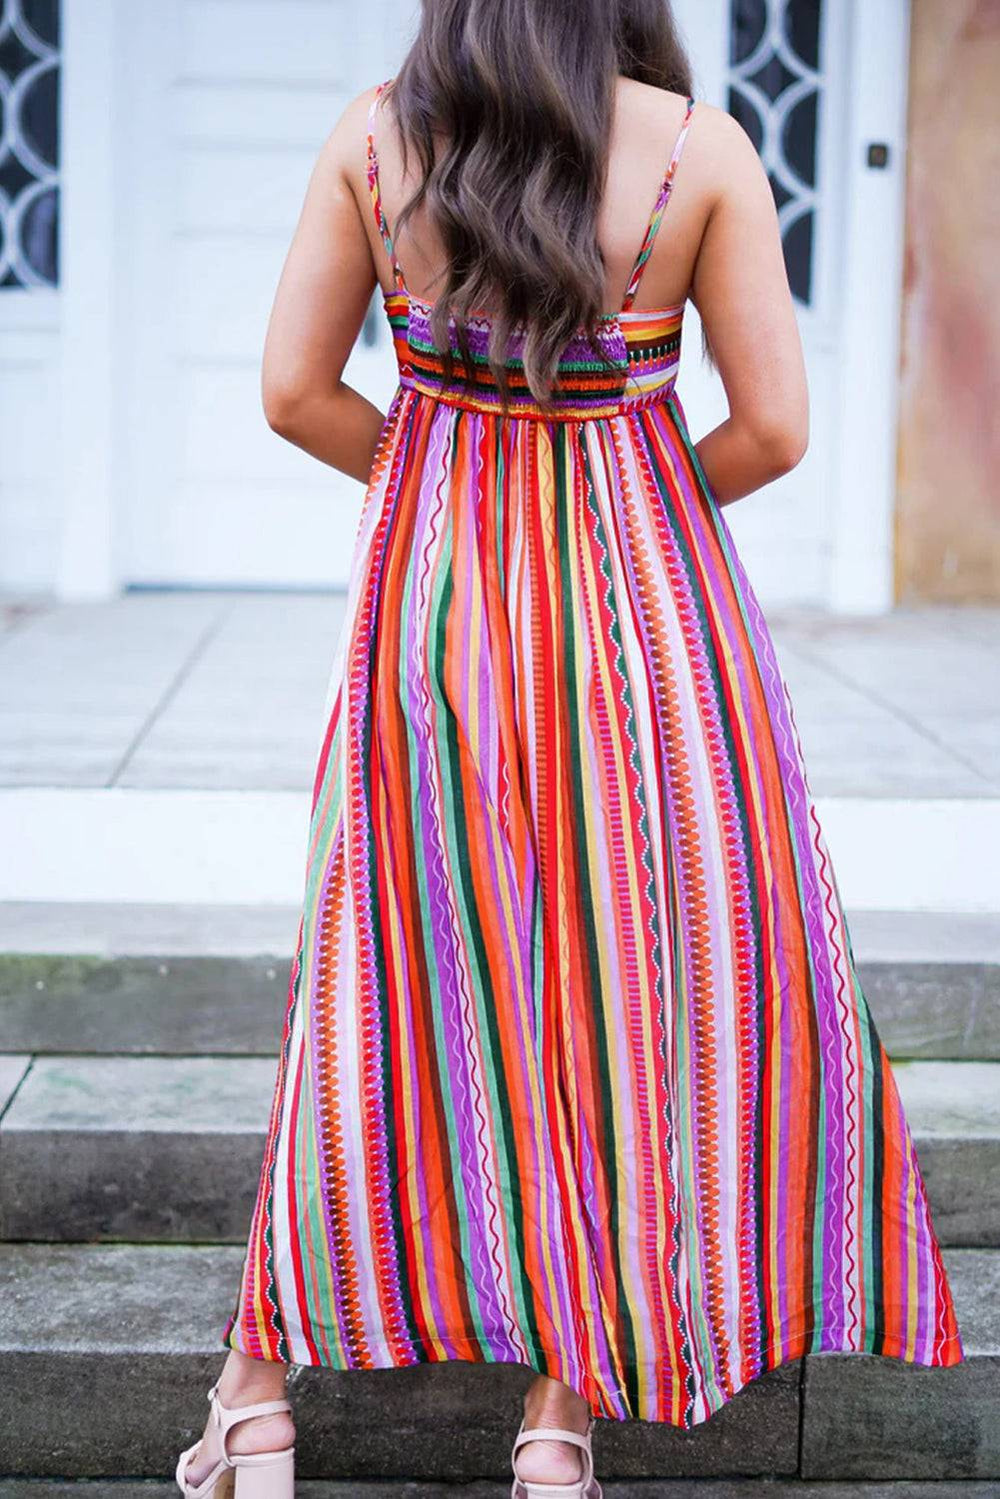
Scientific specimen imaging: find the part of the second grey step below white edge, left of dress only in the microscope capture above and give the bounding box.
[0,1057,277,1243]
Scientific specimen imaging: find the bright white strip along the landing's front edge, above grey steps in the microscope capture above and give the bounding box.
[0,787,1000,911]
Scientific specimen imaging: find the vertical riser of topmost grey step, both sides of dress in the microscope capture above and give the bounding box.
[0,953,1000,1060]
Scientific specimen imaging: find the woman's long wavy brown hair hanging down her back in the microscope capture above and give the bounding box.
[387,0,691,405]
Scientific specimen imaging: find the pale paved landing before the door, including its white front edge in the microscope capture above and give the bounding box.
[0,592,1000,911]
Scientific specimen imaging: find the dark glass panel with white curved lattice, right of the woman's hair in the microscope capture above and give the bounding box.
[727,0,823,306]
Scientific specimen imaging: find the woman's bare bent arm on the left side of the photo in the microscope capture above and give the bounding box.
[261,91,385,484]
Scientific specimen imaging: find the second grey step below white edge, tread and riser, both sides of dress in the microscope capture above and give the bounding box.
[0,1055,1000,1247]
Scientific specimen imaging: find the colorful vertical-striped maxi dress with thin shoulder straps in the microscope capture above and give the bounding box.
[223,85,963,1427]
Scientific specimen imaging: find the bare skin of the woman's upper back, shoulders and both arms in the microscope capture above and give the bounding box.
[264,64,808,491]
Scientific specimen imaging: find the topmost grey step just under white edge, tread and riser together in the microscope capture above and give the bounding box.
[0,902,1000,1060]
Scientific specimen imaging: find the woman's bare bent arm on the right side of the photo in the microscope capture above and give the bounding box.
[691,111,810,505]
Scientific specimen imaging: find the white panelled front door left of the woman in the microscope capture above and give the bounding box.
[115,0,411,586]
